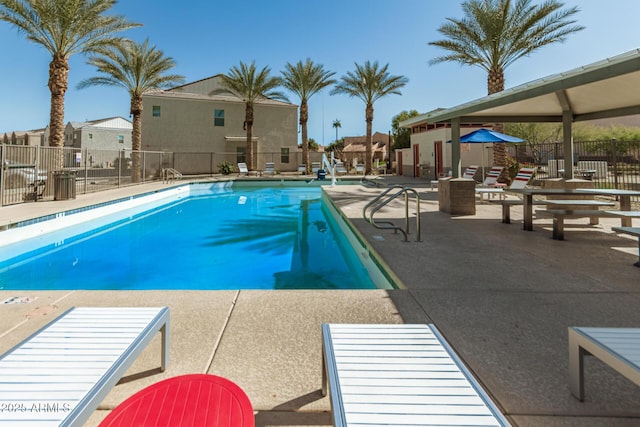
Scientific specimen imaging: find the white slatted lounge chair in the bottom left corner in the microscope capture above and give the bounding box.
[0,307,169,427]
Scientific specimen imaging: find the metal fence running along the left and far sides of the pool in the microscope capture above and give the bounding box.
[0,144,322,206]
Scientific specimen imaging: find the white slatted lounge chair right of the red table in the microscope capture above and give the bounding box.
[322,324,510,426]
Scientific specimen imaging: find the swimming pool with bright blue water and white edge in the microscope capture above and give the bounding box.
[0,183,392,290]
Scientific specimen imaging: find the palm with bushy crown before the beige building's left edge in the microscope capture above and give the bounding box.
[78,39,184,182]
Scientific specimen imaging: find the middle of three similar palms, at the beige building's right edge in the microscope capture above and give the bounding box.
[282,58,336,173]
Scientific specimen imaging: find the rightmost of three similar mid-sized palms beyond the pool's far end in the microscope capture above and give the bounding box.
[331,61,409,174]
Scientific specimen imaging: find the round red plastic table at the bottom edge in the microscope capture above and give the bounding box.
[100,374,254,427]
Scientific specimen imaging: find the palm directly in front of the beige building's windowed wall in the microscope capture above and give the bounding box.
[212,61,287,170]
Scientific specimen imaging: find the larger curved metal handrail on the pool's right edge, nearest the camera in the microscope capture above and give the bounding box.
[362,185,422,242]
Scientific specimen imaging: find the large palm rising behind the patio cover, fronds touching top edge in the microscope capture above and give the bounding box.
[429,0,584,179]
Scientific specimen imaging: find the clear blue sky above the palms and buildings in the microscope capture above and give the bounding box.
[0,0,640,144]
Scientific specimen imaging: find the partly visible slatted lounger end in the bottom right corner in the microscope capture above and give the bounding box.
[569,327,640,401]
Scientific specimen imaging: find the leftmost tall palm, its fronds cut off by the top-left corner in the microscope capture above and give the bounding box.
[0,0,140,147]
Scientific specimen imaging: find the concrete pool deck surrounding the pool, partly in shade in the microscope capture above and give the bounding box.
[0,177,640,427]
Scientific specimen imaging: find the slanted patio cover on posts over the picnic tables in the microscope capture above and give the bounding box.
[400,49,640,177]
